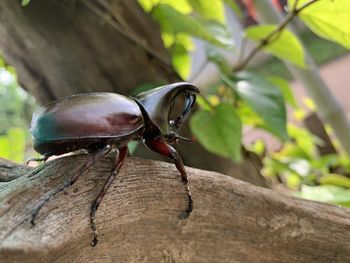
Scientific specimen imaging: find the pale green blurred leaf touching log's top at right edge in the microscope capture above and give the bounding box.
[295,185,350,206]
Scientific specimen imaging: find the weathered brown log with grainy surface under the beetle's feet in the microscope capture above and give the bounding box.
[0,156,350,263]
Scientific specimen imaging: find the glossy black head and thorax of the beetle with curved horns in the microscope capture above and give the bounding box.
[133,82,199,139]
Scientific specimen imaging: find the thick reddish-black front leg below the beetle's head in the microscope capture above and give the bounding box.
[145,139,193,219]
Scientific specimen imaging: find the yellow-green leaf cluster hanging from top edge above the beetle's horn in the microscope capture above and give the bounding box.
[138,0,235,79]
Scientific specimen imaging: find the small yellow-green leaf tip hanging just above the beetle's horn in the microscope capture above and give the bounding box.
[170,44,191,79]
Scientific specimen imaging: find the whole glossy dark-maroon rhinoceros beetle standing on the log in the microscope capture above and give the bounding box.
[31,82,199,246]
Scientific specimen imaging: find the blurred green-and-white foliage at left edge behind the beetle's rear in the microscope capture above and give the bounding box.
[0,58,35,162]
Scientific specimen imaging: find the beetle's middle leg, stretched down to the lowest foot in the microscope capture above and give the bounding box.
[90,147,128,247]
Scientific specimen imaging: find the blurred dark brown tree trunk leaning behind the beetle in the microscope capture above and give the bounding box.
[0,0,266,186]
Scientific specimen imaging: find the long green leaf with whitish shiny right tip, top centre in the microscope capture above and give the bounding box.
[152,4,233,48]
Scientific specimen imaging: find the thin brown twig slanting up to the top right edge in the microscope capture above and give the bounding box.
[233,0,319,72]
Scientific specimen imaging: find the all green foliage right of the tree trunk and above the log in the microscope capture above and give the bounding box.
[139,0,350,205]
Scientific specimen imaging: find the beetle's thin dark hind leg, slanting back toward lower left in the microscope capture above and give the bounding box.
[30,145,112,225]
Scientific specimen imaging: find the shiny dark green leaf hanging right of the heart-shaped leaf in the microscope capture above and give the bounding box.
[222,72,288,140]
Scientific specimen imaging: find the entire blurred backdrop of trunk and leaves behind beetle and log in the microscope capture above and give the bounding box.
[0,0,350,206]
